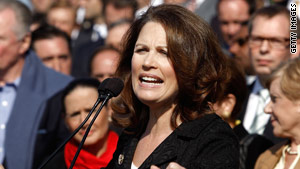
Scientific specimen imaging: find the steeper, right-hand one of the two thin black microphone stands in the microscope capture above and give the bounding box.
[69,93,112,169]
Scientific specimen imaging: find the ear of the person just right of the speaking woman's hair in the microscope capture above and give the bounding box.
[220,94,236,118]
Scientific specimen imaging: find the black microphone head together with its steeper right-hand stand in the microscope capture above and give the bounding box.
[69,78,124,169]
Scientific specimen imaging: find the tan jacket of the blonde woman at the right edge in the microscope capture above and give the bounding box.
[255,141,300,169]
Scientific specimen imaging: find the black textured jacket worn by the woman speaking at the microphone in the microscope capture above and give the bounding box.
[107,114,239,169]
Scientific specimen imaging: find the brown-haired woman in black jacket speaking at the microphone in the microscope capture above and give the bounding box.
[107,5,239,169]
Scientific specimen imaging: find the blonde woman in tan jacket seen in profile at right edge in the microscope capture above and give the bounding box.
[255,58,300,169]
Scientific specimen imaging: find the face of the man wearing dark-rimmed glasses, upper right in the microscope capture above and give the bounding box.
[249,15,290,76]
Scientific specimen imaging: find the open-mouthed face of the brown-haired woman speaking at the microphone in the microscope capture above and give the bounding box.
[131,22,178,108]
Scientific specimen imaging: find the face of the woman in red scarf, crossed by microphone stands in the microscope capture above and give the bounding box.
[65,87,109,146]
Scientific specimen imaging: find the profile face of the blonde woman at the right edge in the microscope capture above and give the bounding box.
[265,78,300,138]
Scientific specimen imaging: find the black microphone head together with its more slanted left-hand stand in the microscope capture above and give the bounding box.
[39,78,124,169]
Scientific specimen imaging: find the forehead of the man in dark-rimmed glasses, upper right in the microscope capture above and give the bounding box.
[251,15,290,37]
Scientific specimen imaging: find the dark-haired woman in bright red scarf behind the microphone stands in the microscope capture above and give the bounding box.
[45,78,118,169]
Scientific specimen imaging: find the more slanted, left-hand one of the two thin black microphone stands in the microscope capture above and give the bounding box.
[39,96,103,169]
